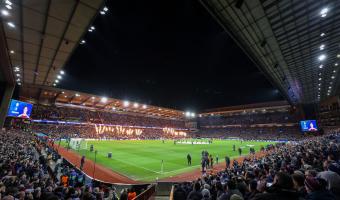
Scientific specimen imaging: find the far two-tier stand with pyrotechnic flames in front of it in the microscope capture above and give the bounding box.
[24,105,185,139]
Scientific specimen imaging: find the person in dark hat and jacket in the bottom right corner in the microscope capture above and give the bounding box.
[305,177,336,200]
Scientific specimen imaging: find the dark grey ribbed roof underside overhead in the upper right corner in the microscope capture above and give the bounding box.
[201,0,340,104]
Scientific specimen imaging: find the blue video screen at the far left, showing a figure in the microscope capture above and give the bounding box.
[7,99,33,119]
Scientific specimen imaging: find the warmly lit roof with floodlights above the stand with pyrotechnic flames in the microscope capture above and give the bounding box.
[20,84,185,119]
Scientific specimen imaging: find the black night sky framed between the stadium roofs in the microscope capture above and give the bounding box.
[60,0,282,111]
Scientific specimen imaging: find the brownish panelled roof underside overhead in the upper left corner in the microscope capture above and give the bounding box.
[0,0,104,86]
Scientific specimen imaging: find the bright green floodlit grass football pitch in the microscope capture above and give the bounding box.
[64,140,270,181]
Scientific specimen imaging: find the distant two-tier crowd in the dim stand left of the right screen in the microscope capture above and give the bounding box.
[196,110,305,140]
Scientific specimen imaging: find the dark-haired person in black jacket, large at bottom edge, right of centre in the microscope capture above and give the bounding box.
[252,172,300,200]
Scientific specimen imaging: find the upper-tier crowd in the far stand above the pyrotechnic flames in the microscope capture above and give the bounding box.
[31,105,185,128]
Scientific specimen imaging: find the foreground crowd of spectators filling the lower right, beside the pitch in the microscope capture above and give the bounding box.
[173,129,340,200]
